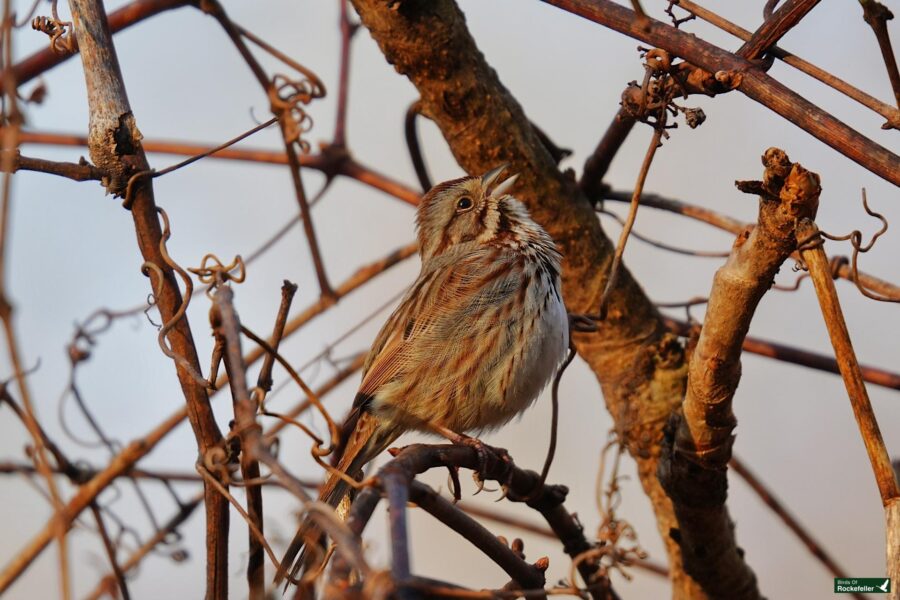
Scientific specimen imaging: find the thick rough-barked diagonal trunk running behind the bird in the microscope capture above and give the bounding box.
[353,0,702,598]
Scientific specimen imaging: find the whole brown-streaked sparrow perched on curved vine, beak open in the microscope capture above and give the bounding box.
[275,164,569,584]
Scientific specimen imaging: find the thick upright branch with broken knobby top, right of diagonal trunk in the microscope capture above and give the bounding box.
[659,148,820,599]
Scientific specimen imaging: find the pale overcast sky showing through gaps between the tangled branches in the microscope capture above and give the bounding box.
[0,0,900,599]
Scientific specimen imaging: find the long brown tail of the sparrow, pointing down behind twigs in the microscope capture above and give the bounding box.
[275,411,388,586]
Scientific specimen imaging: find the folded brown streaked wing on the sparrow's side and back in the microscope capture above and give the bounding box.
[359,248,528,396]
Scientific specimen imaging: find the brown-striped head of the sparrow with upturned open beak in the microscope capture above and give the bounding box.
[416,164,527,262]
